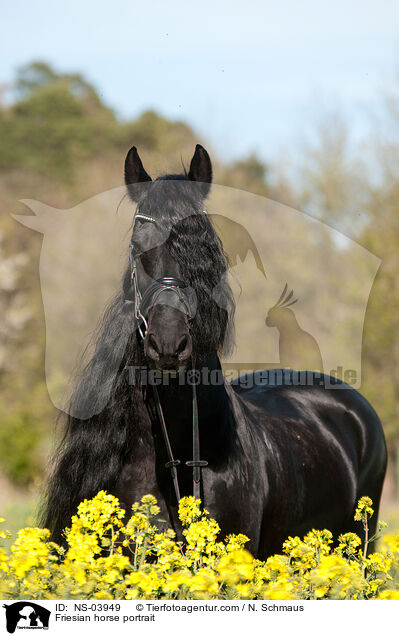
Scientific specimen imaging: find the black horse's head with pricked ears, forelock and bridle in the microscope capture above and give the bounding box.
[123,145,234,369]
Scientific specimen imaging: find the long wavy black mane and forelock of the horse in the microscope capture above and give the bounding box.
[42,175,235,541]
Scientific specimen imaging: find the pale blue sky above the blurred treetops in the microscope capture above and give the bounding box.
[0,0,399,160]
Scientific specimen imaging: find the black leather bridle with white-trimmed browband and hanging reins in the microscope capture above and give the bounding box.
[129,210,208,503]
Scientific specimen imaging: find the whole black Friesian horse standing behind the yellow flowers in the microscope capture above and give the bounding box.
[44,145,386,558]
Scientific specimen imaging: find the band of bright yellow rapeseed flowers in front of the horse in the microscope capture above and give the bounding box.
[0,491,399,600]
